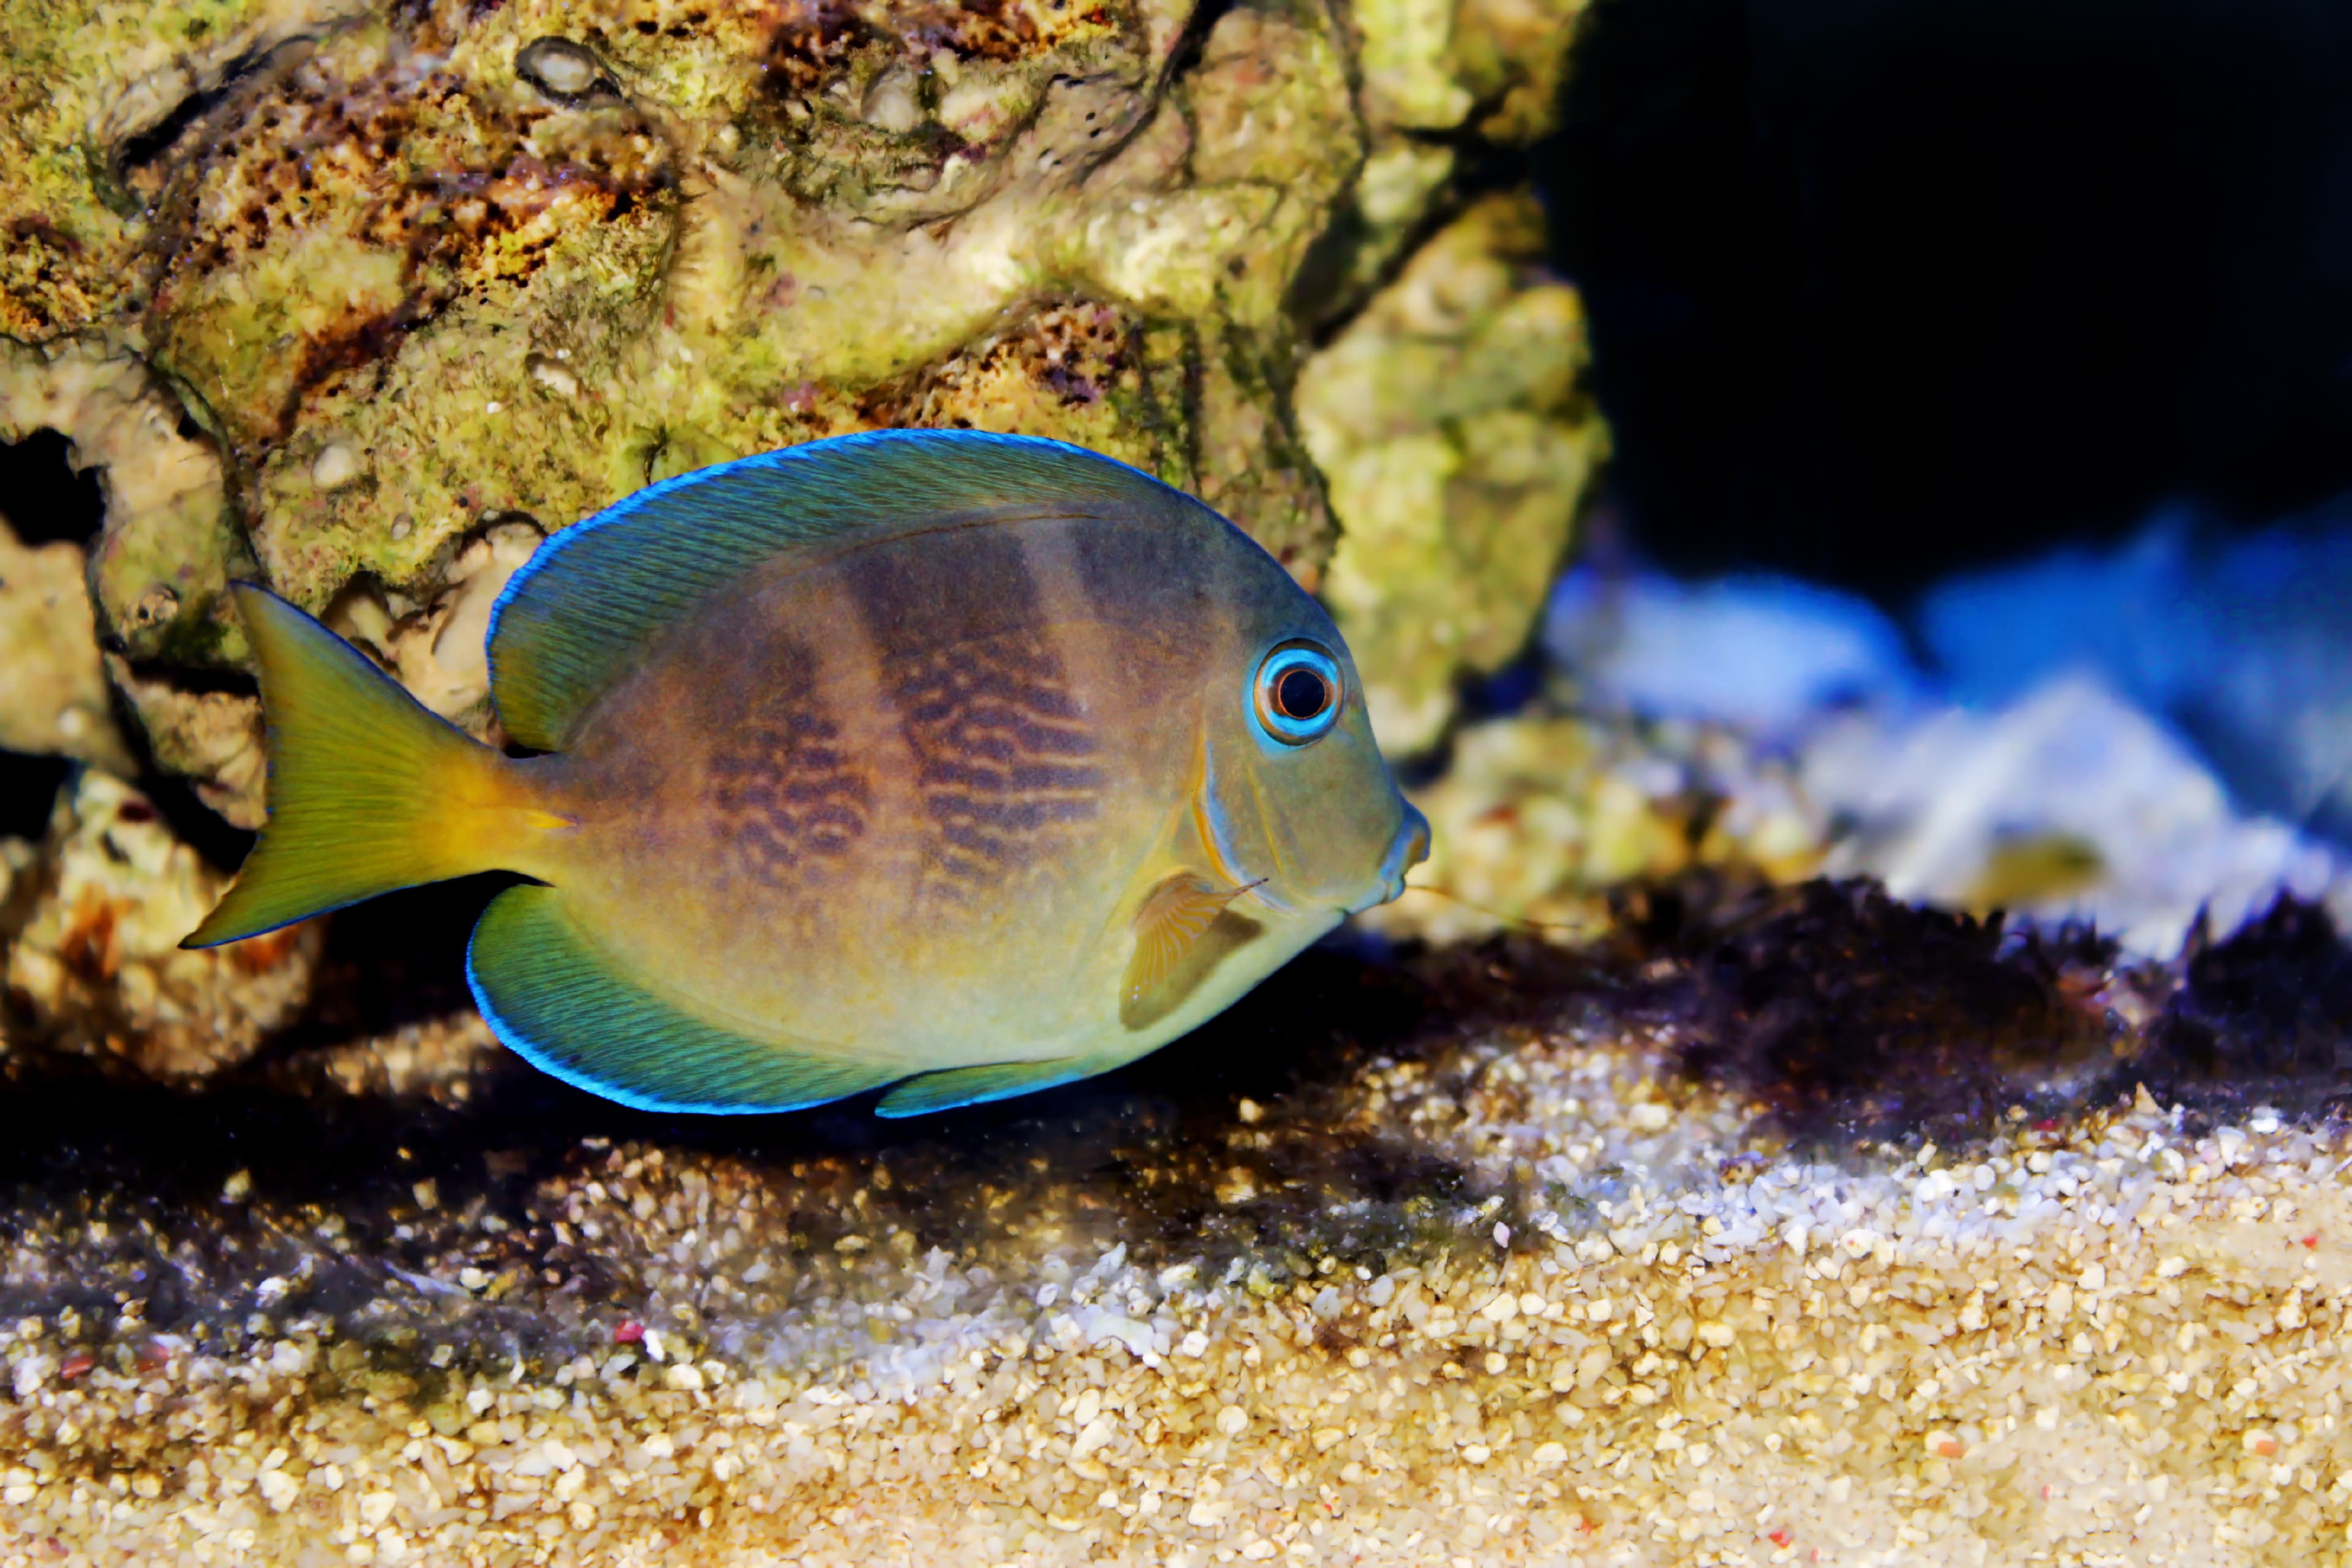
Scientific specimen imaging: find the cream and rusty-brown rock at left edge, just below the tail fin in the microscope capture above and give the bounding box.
[0,771,320,1077]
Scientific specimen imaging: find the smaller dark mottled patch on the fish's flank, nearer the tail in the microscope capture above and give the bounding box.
[710,642,873,884]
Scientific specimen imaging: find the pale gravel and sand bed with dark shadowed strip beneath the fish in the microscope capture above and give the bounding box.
[0,926,2352,1566]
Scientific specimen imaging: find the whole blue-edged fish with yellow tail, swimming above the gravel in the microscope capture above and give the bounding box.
[190,432,1428,1114]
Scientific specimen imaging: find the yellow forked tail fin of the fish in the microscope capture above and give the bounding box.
[181,583,555,948]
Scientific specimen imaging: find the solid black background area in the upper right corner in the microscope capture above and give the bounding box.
[1538,0,2352,597]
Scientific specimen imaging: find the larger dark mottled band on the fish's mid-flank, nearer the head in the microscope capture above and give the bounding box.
[849,529,1103,898]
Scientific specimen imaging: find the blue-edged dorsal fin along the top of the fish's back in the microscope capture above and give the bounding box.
[489,430,1199,750]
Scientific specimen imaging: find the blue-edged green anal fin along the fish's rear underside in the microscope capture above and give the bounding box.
[466,884,908,1114]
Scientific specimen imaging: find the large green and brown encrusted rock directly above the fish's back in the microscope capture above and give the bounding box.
[148,5,1360,625]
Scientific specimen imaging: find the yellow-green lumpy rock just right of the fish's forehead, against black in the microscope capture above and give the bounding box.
[1298,197,1607,752]
